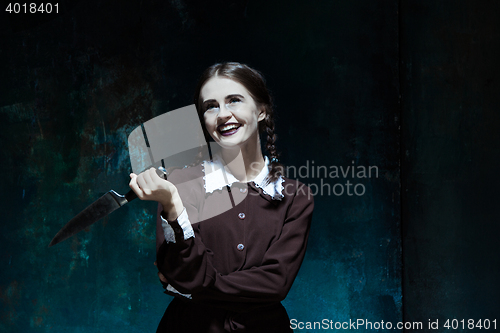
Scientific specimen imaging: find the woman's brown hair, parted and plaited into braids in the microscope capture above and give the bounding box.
[194,62,283,182]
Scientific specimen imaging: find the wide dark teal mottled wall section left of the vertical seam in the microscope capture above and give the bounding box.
[0,0,402,333]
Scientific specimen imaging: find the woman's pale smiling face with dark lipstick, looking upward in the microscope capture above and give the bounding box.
[200,76,265,148]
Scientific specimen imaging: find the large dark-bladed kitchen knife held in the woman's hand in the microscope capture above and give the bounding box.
[49,167,168,247]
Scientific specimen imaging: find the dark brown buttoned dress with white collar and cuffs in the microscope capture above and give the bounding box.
[157,156,314,333]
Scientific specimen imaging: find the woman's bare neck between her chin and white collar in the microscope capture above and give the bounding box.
[221,136,266,182]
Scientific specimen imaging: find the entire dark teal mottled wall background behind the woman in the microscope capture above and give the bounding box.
[0,0,500,333]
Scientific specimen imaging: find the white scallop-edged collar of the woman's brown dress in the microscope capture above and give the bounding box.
[202,155,284,200]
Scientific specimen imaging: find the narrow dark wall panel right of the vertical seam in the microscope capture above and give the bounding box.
[400,1,500,326]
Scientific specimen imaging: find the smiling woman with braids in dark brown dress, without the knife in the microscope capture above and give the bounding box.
[130,63,313,333]
